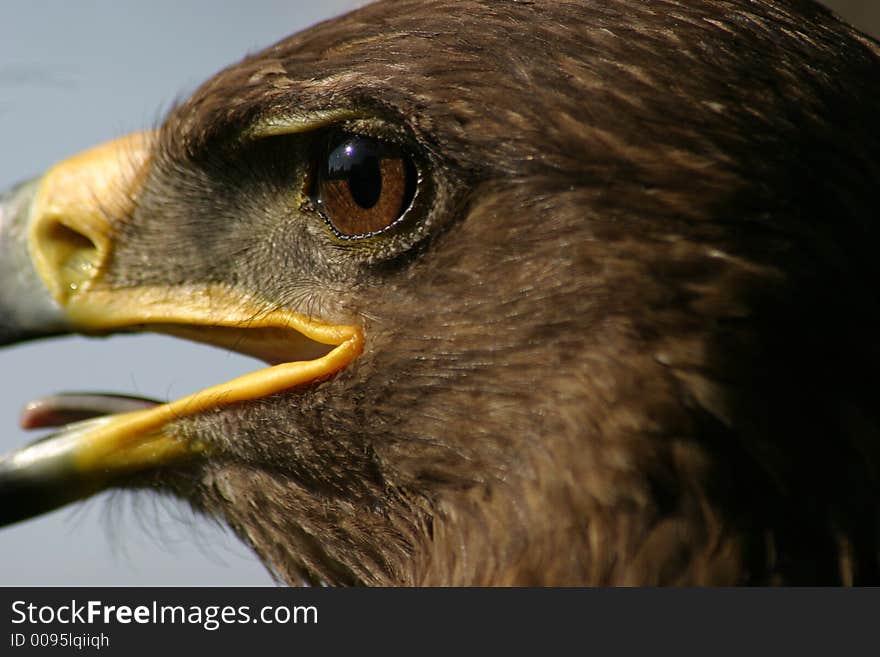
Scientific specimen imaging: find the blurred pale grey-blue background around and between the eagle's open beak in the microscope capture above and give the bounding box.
[0,0,880,585]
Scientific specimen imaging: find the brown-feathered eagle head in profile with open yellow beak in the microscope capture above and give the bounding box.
[0,0,880,584]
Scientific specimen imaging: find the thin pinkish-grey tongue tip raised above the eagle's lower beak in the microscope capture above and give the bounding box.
[19,392,159,429]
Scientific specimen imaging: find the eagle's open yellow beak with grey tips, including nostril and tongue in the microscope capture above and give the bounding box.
[0,133,363,525]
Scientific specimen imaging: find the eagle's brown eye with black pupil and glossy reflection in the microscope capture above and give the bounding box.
[314,134,417,239]
